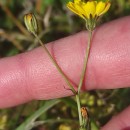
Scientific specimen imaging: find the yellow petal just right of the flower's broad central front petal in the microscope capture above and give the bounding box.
[95,1,106,16]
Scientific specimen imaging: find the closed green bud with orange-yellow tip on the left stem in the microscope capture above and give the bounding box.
[24,13,38,34]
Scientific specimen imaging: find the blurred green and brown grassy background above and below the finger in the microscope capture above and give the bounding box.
[0,0,130,130]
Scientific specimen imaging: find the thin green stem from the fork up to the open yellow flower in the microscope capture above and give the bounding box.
[78,31,92,94]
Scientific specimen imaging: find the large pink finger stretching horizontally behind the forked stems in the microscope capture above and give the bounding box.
[0,17,130,108]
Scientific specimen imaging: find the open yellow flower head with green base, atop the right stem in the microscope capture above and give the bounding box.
[67,0,111,29]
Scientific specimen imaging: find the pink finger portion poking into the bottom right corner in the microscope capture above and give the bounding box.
[101,106,130,130]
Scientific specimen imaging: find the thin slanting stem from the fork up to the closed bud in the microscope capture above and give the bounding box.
[34,33,77,95]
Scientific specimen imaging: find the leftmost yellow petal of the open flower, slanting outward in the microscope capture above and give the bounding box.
[67,2,84,19]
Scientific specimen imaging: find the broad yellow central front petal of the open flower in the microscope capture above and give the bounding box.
[83,1,96,19]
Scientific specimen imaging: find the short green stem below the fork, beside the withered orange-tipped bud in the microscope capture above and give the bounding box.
[76,94,82,127]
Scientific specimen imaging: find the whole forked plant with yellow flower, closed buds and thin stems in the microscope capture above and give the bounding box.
[24,0,111,130]
